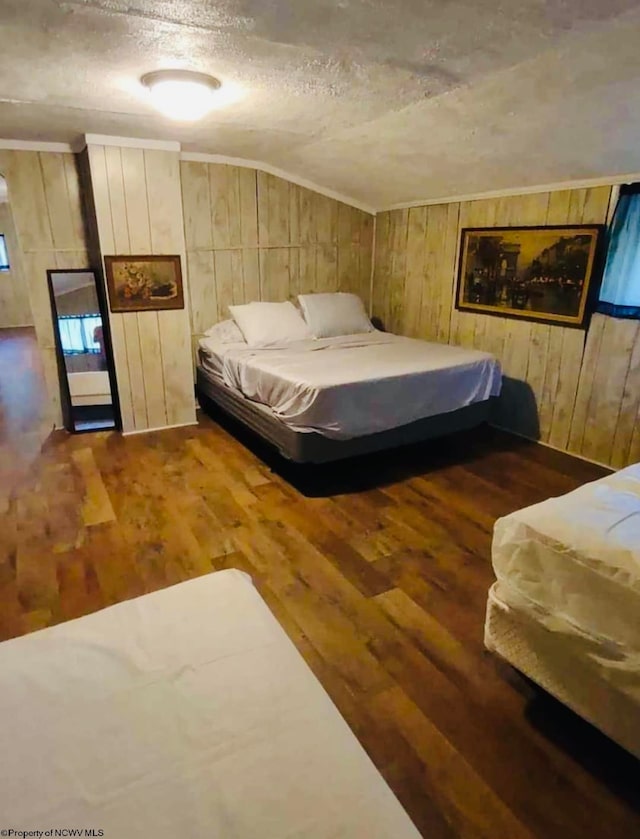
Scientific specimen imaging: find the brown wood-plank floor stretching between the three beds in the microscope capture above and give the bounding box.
[0,416,640,839]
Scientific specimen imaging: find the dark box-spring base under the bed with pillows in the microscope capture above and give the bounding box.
[196,367,491,463]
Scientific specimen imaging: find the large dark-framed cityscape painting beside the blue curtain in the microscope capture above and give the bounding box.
[456,225,604,327]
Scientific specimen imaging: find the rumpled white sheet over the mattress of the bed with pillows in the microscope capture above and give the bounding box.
[200,332,501,439]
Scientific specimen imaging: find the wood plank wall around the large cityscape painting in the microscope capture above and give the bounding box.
[373,187,640,467]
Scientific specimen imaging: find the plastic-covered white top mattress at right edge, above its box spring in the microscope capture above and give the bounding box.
[492,464,640,652]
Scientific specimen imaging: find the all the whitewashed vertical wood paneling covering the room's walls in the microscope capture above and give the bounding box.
[0,146,640,467]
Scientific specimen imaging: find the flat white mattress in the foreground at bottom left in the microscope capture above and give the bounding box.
[0,571,419,839]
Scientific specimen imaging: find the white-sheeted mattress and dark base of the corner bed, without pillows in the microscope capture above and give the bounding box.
[197,330,501,463]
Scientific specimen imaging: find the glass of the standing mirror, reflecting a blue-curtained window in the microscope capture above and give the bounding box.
[48,270,115,431]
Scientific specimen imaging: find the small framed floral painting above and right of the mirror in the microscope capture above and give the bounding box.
[104,255,184,312]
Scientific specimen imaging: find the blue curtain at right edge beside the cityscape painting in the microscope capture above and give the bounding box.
[598,192,640,318]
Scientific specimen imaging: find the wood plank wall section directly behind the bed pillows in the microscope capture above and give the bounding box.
[180,161,373,347]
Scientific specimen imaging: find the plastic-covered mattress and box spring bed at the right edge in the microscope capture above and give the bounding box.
[485,464,640,757]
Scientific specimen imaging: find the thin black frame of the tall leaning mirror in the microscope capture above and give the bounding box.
[47,268,122,434]
